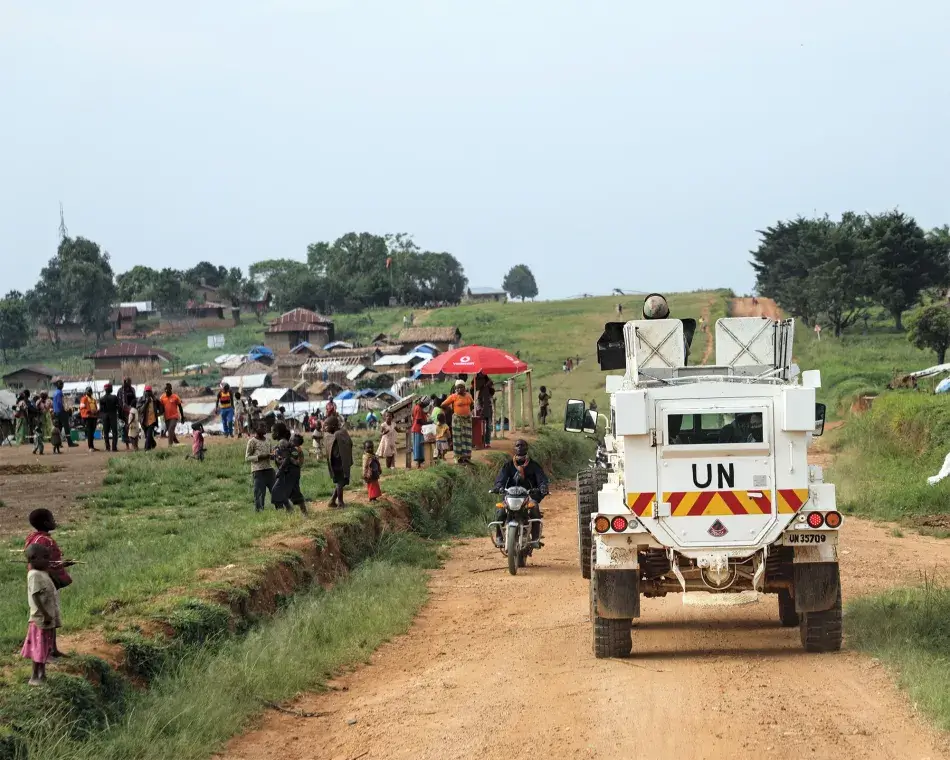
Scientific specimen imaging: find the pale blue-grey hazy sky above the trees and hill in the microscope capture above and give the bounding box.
[0,0,950,298]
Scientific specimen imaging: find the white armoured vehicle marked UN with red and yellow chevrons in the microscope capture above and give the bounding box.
[565,295,842,657]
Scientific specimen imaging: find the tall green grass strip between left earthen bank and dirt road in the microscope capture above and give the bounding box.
[14,540,434,760]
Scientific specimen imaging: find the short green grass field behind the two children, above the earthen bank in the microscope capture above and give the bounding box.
[0,443,342,650]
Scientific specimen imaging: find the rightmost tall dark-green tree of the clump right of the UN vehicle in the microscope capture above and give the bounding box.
[865,210,950,330]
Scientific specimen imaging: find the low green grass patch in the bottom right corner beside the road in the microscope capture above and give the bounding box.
[845,581,950,731]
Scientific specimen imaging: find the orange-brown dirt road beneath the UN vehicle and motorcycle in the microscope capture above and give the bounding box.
[222,490,950,760]
